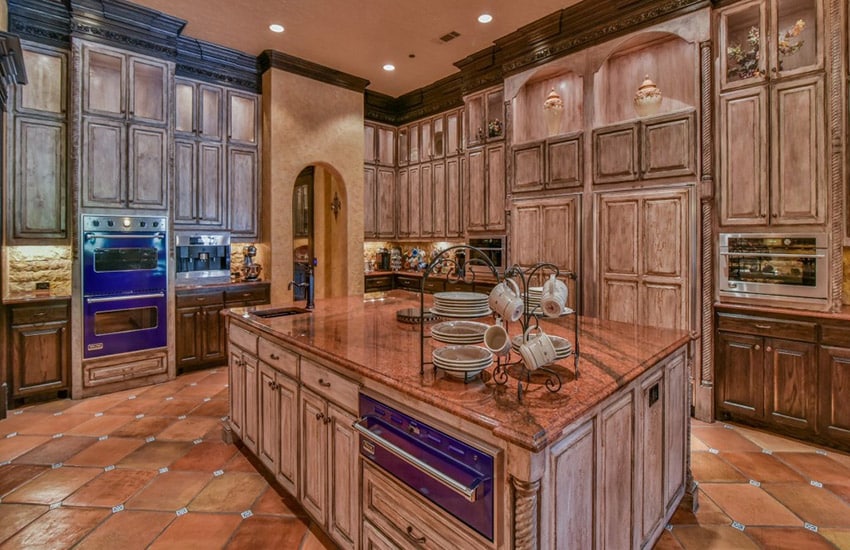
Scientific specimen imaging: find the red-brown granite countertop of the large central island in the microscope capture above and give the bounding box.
[229,292,690,451]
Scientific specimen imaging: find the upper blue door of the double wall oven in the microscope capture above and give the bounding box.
[83,232,167,296]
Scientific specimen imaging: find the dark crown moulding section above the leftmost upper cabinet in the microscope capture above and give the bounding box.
[8,0,71,48]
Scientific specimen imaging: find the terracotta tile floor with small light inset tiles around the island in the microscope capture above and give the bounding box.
[0,368,850,550]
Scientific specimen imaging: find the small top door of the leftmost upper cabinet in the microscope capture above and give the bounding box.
[16,45,68,115]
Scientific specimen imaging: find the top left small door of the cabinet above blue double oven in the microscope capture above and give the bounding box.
[83,45,127,118]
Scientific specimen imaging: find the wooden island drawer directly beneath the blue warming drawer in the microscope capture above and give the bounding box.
[361,461,489,550]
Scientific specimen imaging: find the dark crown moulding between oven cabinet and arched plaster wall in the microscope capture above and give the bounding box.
[175,36,262,93]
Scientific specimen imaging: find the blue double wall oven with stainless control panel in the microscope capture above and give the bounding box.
[80,215,168,359]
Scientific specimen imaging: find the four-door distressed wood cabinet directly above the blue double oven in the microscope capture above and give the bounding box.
[74,42,174,210]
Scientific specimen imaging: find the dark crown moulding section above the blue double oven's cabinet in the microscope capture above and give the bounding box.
[66,0,186,59]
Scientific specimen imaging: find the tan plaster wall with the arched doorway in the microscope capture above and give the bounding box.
[262,69,363,303]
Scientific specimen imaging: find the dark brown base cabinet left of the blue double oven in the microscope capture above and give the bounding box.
[7,300,71,408]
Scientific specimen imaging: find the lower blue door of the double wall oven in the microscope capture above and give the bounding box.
[83,292,168,358]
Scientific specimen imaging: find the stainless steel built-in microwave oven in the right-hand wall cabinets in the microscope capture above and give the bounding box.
[719,233,829,300]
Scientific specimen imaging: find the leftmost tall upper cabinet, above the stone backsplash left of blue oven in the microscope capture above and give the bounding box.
[6,44,68,244]
